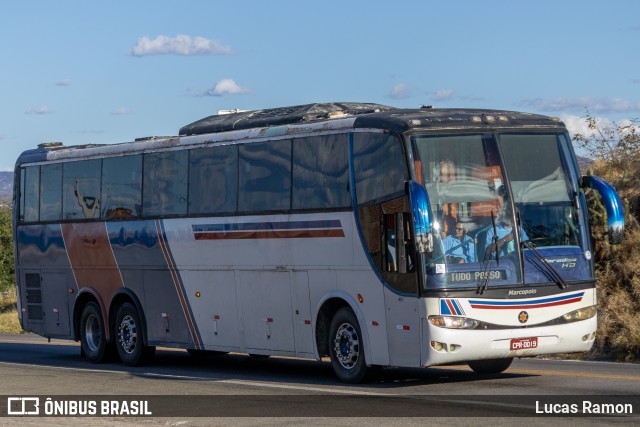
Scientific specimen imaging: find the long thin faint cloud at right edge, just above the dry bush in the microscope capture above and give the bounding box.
[522,96,640,114]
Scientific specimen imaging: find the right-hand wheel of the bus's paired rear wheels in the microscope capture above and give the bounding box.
[115,302,156,366]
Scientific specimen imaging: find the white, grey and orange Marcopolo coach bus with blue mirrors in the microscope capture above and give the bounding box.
[13,102,624,383]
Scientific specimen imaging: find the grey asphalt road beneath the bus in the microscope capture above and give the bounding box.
[0,335,640,426]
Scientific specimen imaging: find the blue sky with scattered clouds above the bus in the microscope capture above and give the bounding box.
[0,0,640,171]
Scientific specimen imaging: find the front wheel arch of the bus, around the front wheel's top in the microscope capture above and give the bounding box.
[314,291,371,360]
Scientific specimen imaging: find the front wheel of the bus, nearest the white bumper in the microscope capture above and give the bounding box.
[329,307,367,384]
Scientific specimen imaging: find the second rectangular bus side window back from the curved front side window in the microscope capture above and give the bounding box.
[238,140,291,212]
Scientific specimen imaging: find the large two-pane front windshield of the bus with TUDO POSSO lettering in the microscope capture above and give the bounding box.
[412,133,593,289]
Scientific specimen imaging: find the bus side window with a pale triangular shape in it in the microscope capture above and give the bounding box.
[62,160,101,219]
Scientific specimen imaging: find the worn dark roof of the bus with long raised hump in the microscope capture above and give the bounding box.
[16,102,565,165]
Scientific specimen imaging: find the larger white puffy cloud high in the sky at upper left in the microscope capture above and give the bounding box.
[131,34,231,56]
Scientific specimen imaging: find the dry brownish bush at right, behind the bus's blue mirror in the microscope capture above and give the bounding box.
[573,110,640,361]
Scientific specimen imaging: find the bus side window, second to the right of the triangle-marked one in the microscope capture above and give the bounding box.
[143,150,188,216]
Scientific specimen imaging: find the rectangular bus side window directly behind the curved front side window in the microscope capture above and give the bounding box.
[292,134,351,209]
